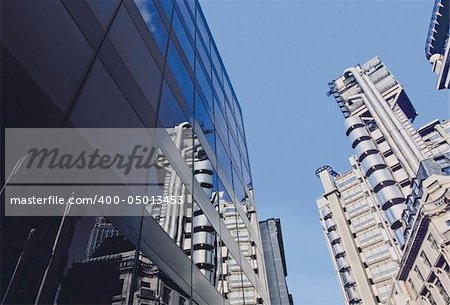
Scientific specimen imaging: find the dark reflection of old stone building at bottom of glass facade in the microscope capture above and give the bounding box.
[58,236,189,305]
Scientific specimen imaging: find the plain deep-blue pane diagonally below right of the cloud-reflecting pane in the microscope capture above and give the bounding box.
[168,42,194,105]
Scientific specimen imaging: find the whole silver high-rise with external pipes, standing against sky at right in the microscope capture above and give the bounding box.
[316,57,449,304]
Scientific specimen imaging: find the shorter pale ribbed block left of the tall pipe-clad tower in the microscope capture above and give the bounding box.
[317,164,400,304]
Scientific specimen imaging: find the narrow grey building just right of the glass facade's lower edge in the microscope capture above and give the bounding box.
[259,218,294,305]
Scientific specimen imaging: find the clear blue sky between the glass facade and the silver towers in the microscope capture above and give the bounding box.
[201,0,450,305]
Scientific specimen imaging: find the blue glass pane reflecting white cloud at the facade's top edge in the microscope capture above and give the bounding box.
[134,0,167,54]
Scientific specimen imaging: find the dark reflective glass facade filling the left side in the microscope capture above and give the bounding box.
[1,0,270,305]
